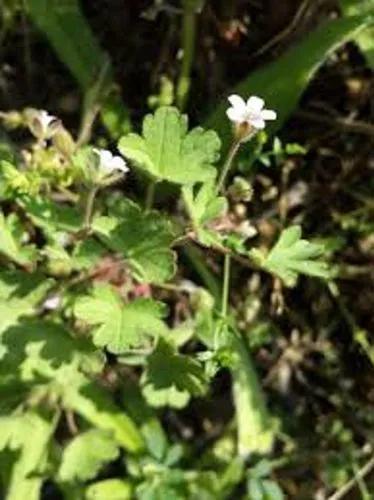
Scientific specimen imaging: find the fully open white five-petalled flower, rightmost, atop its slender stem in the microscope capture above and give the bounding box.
[226,94,277,130]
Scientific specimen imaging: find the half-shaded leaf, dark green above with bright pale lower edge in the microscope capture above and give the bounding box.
[142,339,207,408]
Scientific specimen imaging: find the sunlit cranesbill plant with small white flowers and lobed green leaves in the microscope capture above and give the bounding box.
[0,95,329,500]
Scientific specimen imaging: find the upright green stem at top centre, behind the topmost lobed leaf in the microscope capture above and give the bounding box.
[176,0,196,110]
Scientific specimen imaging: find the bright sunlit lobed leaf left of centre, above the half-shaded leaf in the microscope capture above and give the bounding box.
[74,285,166,354]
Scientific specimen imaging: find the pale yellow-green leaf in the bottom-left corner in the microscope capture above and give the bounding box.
[0,411,55,500]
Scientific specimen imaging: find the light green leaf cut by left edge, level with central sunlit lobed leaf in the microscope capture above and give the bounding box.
[0,271,53,335]
